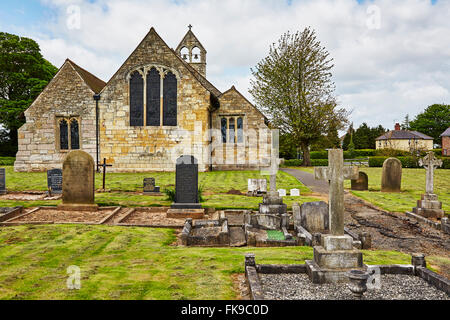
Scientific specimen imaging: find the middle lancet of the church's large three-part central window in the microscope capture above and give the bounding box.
[147,68,161,126]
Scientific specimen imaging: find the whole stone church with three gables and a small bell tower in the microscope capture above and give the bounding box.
[14,26,271,172]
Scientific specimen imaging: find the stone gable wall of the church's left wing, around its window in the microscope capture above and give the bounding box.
[14,61,95,171]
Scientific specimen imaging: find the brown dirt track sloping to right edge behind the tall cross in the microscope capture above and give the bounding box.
[345,194,450,277]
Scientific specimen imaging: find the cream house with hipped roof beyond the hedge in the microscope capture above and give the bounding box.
[375,123,433,152]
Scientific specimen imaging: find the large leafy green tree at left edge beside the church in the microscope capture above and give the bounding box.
[0,32,58,155]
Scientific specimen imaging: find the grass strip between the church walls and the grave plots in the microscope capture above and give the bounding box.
[0,166,317,210]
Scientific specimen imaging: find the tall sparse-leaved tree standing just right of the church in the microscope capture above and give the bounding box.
[250,28,348,166]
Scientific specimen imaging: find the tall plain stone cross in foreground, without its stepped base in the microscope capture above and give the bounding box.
[314,149,359,236]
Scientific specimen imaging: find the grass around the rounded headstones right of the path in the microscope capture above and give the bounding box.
[291,167,450,212]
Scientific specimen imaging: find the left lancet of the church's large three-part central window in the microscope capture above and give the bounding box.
[130,71,144,126]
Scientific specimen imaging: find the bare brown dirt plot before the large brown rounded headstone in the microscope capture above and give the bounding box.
[10,208,115,223]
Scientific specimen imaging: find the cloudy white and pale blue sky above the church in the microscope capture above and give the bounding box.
[0,0,450,129]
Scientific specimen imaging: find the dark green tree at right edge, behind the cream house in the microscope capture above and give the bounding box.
[409,104,450,143]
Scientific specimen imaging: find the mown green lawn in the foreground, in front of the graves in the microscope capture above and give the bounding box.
[0,225,416,300]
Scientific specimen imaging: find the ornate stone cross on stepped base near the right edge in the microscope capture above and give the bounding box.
[413,151,444,219]
